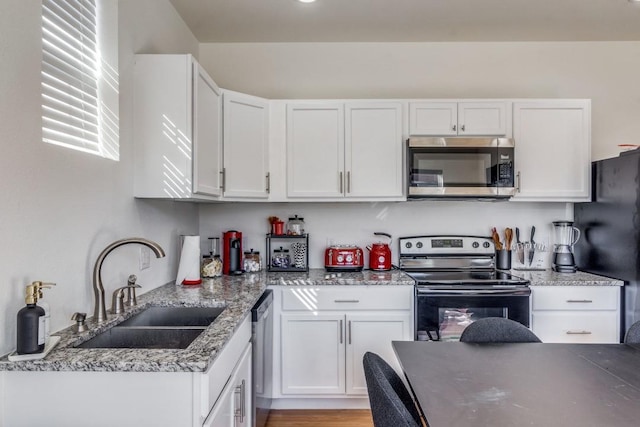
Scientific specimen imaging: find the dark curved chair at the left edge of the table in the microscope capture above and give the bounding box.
[362,352,422,427]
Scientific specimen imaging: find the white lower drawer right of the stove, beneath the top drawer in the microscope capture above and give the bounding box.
[531,311,619,343]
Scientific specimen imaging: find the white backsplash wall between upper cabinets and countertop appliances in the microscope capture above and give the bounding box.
[200,201,573,268]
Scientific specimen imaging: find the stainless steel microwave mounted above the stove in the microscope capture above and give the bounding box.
[407,137,515,199]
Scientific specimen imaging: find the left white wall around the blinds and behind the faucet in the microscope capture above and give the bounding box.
[0,0,198,354]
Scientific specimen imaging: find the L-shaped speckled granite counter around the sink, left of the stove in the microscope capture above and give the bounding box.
[0,269,413,372]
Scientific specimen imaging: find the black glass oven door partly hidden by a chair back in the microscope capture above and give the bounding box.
[415,287,531,341]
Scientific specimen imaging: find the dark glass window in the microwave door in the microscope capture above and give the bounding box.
[411,150,495,187]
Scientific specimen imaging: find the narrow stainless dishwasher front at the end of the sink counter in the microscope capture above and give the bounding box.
[251,289,273,427]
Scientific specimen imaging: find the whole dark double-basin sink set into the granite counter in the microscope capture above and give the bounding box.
[76,307,225,349]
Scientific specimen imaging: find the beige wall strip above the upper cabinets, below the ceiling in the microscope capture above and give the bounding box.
[200,42,640,160]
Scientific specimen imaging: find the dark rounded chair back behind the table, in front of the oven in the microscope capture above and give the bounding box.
[460,317,542,343]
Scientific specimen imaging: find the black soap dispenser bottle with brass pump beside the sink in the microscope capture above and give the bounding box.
[16,284,45,354]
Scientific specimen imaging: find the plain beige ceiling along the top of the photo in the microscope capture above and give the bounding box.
[170,0,640,43]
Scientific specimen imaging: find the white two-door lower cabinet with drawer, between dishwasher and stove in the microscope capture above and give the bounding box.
[276,285,413,398]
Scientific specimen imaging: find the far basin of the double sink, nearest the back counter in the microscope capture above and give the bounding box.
[116,307,225,328]
